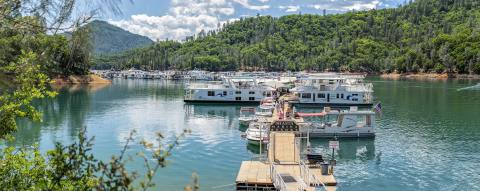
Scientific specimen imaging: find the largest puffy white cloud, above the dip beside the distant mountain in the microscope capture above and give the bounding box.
[109,0,270,40]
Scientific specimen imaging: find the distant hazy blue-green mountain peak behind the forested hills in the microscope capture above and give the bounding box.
[86,20,153,55]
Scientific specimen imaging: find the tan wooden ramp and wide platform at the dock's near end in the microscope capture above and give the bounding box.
[236,132,337,191]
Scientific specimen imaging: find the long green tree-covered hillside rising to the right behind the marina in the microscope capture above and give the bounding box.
[94,0,480,73]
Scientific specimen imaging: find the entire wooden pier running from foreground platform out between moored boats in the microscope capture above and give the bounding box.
[235,97,337,191]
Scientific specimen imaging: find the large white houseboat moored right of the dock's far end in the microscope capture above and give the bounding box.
[290,73,373,106]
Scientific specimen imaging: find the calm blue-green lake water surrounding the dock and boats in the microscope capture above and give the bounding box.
[8,78,480,190]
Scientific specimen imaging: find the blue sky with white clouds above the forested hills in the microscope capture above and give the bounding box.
[91,0,404,40]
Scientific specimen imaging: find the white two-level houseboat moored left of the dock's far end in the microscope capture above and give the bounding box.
[184,77,275,102]
